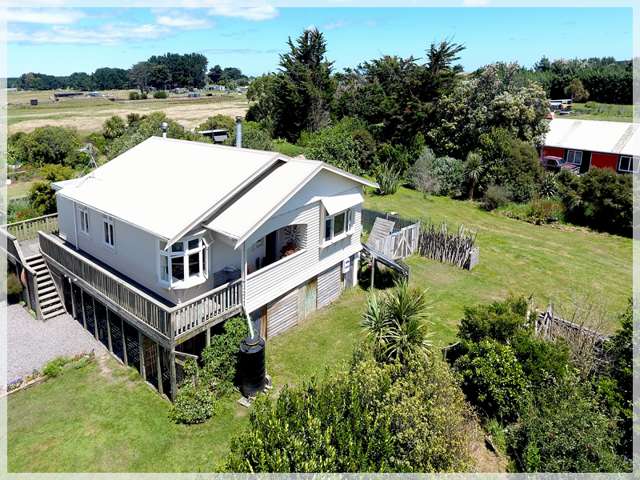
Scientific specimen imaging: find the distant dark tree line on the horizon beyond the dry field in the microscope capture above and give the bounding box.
[7,53,249,92]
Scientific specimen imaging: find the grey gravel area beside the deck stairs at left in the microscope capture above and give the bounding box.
[7,305,107,383]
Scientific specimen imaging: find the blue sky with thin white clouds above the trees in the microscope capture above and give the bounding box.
[7,6,632,76]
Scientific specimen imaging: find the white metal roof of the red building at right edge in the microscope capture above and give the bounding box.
[544,118,640,155]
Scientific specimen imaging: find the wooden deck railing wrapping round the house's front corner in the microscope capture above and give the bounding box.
[40,232,242,342]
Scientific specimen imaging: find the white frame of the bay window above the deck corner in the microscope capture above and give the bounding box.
[158,235,209,288]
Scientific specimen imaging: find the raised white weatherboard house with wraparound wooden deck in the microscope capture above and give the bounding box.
[40,137,377,396]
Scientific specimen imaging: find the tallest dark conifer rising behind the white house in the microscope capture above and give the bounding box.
[274,29,335,141]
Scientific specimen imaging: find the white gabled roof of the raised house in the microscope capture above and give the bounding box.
[56,137,377,240]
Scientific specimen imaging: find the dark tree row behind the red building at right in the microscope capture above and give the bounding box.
[523,57,633,105]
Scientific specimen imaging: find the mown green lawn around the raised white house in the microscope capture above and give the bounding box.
[8,189,632,472]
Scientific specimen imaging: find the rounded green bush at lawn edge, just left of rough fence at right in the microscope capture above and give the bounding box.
[458,297,535,343]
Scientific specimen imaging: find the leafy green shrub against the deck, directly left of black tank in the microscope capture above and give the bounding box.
[202,317,249,382]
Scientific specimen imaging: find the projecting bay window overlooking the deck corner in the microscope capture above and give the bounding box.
[159,237,207,286]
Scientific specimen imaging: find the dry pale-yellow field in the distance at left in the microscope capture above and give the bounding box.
[7,90,249,134]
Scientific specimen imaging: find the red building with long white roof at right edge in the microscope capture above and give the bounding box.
[540,118,640,173]
